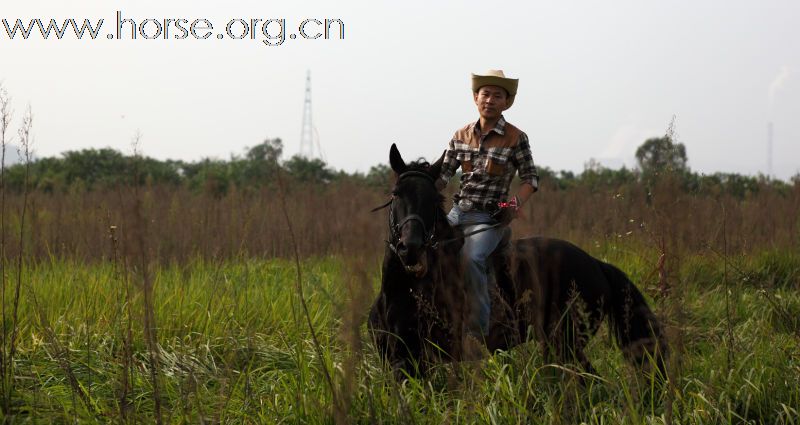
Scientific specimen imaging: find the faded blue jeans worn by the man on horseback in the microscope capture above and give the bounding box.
[447,205,507,339]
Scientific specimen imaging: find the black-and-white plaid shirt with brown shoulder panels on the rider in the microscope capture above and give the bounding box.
[441,116,539,207]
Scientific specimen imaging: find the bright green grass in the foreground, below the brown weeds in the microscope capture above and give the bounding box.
[5,252,800,424]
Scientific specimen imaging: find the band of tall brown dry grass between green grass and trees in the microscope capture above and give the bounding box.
[0,175,800,264]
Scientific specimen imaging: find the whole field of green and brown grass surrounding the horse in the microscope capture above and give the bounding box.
[0,159,800,424]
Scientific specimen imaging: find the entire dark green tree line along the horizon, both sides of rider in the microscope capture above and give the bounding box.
[3,136,800,199]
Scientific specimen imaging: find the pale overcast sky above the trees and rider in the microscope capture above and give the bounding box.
[0,0,800,179]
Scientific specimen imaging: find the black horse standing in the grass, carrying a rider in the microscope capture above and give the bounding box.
[368,145,666,376]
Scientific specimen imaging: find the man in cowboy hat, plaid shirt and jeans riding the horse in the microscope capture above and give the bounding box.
[437,70,539,340]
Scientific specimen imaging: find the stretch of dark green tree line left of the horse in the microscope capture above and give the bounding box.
[4,138,388,195]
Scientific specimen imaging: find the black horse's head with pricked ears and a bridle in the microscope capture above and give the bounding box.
[380,144,444,278]
